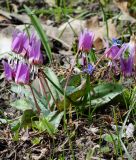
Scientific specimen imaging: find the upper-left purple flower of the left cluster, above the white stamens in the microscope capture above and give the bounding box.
[11,32,28,56]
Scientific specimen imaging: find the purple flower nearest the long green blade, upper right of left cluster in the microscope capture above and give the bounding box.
[29,40,43,64]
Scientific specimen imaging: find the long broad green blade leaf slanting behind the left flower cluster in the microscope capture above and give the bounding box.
[24,5,52,63]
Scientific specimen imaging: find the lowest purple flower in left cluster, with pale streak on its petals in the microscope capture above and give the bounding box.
[15,63,30,84]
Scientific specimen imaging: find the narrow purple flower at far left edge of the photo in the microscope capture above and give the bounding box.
[2,61,13,81]
